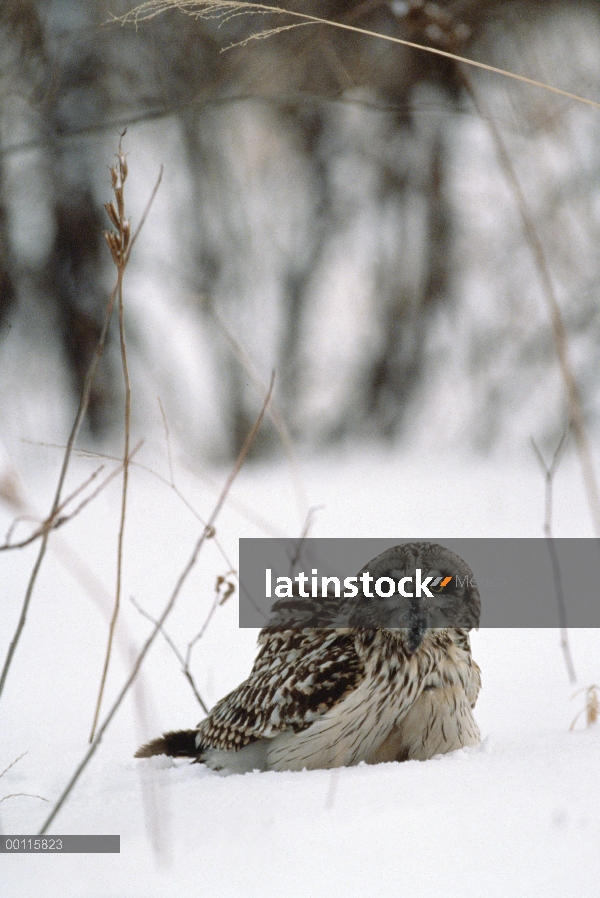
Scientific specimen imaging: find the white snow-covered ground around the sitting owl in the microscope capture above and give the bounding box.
[0,450,600,898]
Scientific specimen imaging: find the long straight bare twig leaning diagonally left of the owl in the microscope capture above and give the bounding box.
[39,375,275,835]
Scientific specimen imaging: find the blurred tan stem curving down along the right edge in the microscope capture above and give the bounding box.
[461,71,600,537]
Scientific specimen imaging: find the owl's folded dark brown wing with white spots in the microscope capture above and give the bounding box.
[196,628,365,753]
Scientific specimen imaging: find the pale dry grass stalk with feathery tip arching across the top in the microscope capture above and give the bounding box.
[117,0,600,109]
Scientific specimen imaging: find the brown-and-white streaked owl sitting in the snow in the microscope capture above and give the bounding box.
[136,542,481,773]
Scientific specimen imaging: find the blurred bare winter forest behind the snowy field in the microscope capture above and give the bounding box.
[0,0,600,458]
